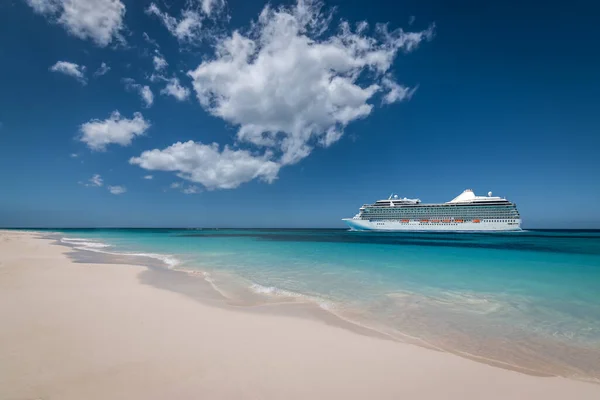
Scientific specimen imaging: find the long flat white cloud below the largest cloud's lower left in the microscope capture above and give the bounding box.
[129,140,280,190]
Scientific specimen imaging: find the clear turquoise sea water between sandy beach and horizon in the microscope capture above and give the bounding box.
[45,229,600,379]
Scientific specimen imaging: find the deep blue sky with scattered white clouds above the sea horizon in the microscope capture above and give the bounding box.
[0,0,600,228]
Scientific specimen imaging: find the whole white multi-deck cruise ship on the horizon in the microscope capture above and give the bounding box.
[343,189,521,231]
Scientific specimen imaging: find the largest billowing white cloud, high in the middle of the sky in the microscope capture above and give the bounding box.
[188,0,433,166]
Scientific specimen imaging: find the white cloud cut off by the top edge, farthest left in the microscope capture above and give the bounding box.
[26,0,125,47]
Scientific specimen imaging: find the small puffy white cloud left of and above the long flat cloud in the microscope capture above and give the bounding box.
[79,111,150,151]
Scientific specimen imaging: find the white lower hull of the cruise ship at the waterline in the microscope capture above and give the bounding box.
[343,218,521,232]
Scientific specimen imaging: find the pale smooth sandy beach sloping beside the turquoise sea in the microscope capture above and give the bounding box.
[0,231,600,400]
